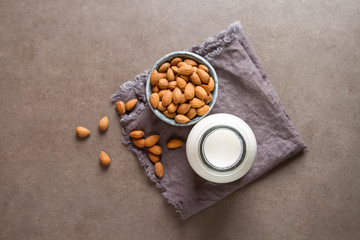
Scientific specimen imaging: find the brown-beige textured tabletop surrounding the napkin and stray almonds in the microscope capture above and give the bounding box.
[0,0,360,240]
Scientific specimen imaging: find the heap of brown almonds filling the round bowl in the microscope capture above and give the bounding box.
[150,57,215,123]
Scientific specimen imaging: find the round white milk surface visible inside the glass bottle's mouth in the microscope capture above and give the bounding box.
[203,128,243,168]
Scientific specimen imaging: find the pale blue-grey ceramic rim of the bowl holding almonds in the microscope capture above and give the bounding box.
[145,51,218,127]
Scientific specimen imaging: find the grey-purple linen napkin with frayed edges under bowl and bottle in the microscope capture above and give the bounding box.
[111,22,306,219]
